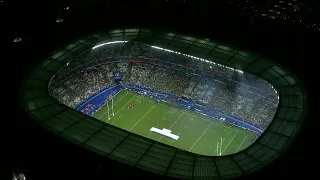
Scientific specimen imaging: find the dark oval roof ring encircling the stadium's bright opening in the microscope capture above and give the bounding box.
[21,29,307,179]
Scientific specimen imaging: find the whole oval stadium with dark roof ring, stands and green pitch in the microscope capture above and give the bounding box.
[22,28,306,179]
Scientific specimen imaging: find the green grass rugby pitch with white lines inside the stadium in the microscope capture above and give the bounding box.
[93,90,257,156]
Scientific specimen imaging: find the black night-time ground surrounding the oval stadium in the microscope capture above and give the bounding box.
[0,0,320,180]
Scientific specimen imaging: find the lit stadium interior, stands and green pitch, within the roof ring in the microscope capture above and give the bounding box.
[49,41,279,156]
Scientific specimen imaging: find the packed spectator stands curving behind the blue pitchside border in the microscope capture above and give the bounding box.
[49,42,278,129]
